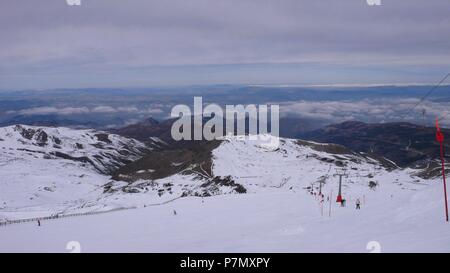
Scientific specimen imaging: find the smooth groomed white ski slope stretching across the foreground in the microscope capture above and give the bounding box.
[0,184,450,252]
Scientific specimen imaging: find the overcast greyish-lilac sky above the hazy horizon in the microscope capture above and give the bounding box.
[0,0,450,89]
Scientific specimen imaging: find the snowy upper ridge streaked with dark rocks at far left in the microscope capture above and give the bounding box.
[0,125,148,171]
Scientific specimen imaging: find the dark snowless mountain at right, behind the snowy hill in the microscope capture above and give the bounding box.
[296,121,450,167]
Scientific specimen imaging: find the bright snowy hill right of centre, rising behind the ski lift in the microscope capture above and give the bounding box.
[213,133,429,195]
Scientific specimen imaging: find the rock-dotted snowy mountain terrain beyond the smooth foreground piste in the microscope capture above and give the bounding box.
[0,125,432,219]
